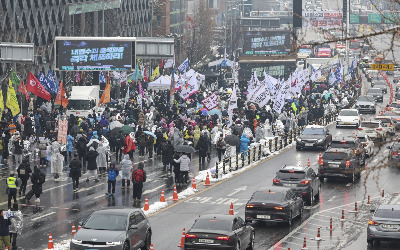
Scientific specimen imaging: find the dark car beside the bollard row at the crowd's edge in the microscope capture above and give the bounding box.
[296,125,332,150]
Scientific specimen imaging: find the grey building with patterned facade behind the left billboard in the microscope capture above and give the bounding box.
[0,0,152,76]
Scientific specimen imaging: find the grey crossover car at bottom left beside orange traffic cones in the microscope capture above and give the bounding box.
[70,208,152,250]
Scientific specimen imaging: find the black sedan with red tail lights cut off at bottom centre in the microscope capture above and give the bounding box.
[185,214,255,250]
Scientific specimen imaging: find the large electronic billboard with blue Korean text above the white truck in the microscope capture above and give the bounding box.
[56,38,135,71]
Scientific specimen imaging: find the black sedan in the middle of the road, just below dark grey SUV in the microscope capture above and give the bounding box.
[245,186,304,226]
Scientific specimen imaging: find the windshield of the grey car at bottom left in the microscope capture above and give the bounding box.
[83,214,127,231]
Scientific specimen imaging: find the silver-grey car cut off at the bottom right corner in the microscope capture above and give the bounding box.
[367,205,400,245]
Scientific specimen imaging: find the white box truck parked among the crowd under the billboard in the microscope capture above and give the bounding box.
[67,85,104,117]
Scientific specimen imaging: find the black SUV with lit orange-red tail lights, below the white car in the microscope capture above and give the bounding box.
[318,148,363,182]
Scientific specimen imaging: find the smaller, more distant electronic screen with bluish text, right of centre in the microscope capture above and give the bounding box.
[243,30,291,56]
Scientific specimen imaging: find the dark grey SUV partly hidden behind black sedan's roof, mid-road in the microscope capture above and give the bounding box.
[273,166,320,205]
